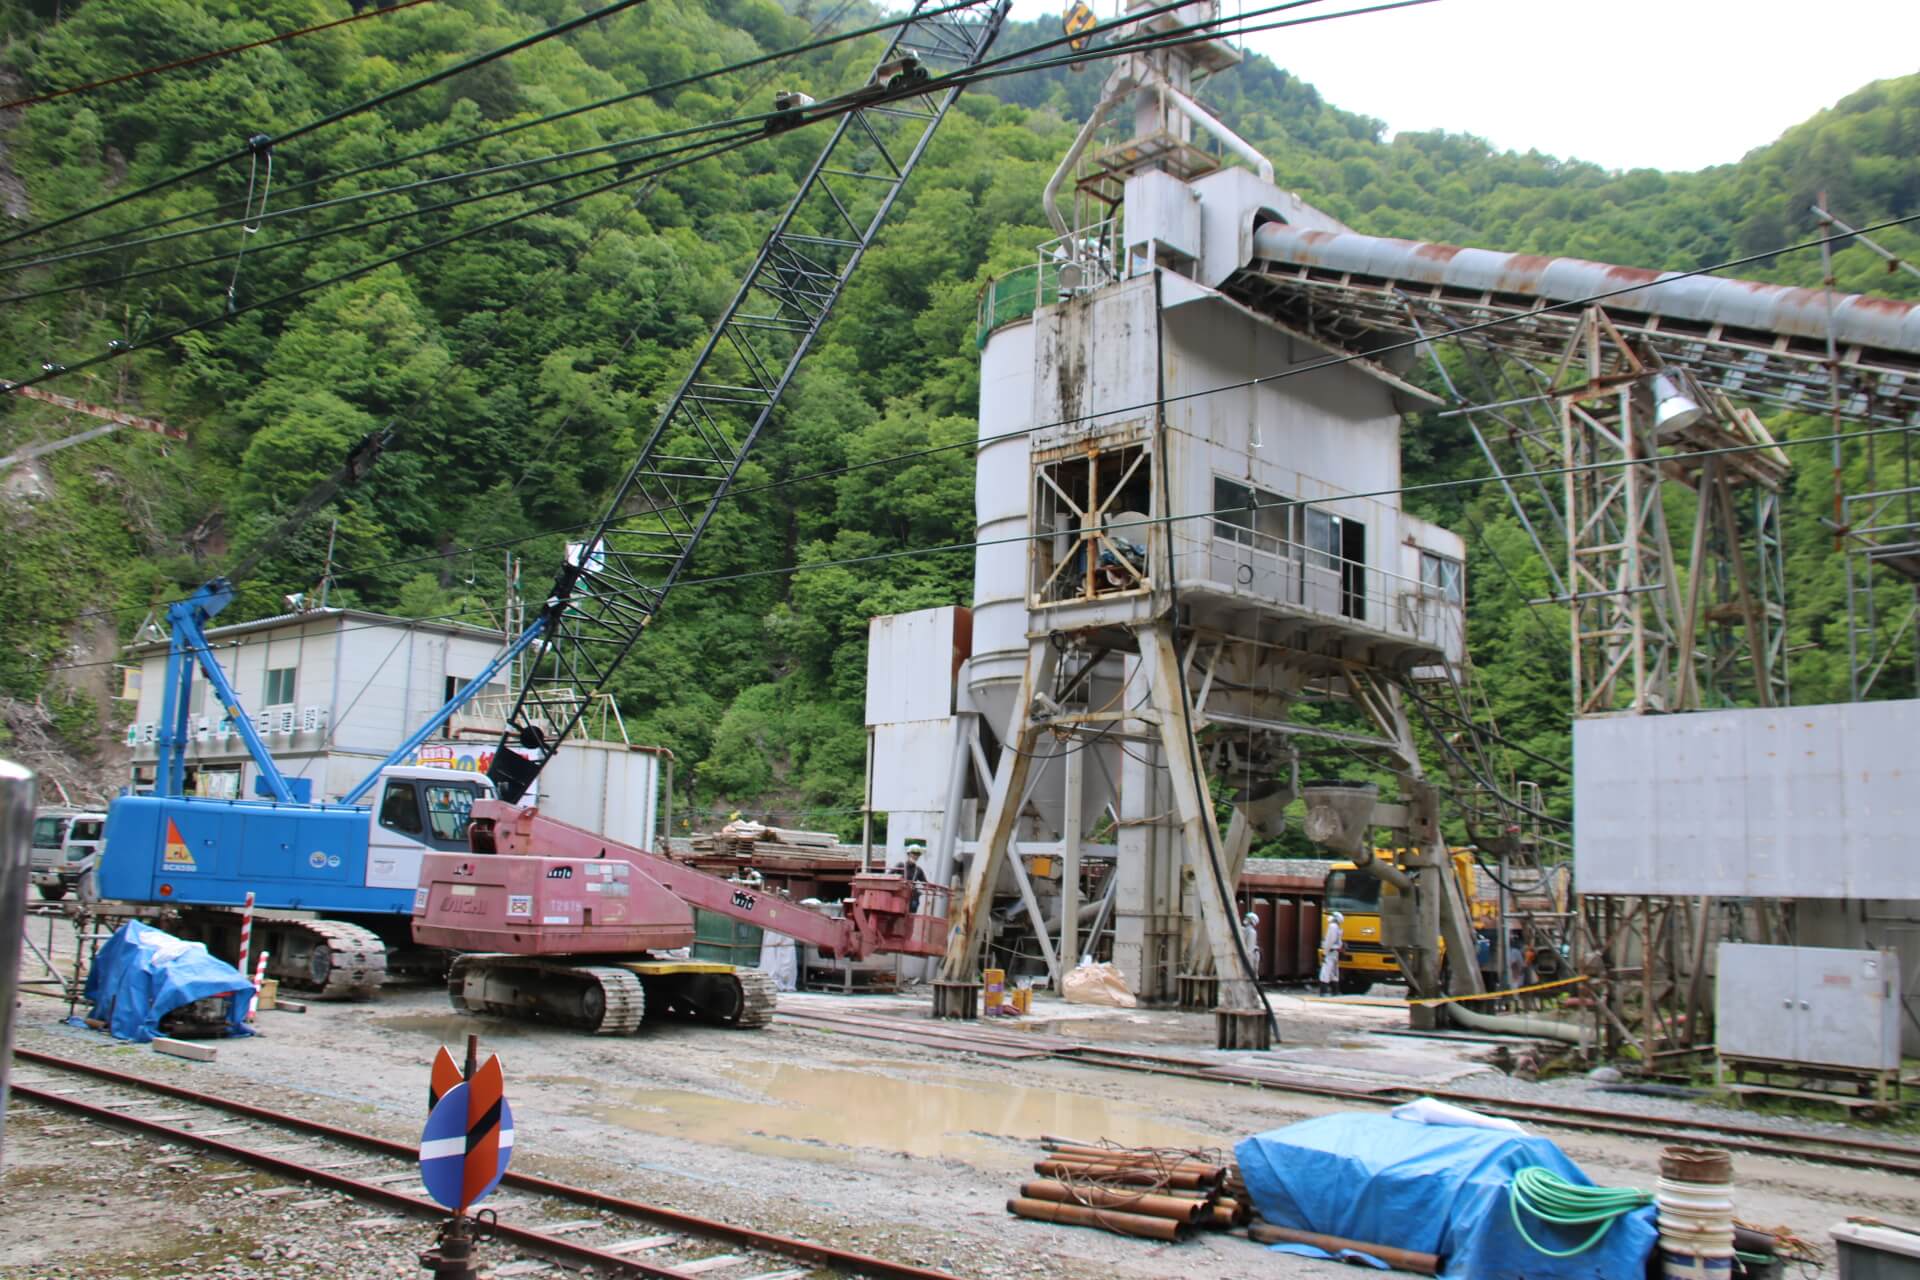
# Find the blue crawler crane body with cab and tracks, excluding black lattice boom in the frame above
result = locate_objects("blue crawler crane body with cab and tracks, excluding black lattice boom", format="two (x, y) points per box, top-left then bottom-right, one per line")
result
(96, 580), (547, 998)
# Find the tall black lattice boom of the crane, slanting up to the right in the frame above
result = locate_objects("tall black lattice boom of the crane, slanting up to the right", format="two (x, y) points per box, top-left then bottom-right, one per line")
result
(488, 0), (1008, 800)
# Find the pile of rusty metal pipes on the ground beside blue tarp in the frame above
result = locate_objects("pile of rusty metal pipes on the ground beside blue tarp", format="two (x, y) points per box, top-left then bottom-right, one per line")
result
(1006, 1138), (1252, 1242)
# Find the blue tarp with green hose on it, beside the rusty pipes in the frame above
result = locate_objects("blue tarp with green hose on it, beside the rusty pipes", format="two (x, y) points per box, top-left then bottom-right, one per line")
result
(1235, 1115), (1657, 1280)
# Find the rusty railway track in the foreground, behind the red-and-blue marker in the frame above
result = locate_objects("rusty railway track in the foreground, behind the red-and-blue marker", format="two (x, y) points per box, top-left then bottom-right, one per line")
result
(0, 1050), (956, 1280)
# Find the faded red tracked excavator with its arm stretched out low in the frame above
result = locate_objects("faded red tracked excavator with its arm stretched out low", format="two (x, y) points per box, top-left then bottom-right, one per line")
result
(413, 800), (947, 1036)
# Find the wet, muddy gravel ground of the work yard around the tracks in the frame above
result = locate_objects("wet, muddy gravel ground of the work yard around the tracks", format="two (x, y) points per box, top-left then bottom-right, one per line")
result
(0, 921), (1920, 1280)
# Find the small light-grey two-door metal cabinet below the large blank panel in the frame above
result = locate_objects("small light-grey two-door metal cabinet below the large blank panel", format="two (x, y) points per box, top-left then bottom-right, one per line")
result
(1715, 942), (1901, 1071)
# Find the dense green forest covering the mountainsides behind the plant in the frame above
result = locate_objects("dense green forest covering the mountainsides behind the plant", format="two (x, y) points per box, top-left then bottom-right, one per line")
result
(0, 0), (1920, 829)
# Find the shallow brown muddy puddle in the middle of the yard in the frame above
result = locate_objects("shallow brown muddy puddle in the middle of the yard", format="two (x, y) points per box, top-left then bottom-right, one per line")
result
(595, 1063), (1219, 1161)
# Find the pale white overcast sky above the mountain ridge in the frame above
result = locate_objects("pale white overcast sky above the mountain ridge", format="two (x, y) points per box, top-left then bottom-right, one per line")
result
(1014, 0), (1920, 169)
